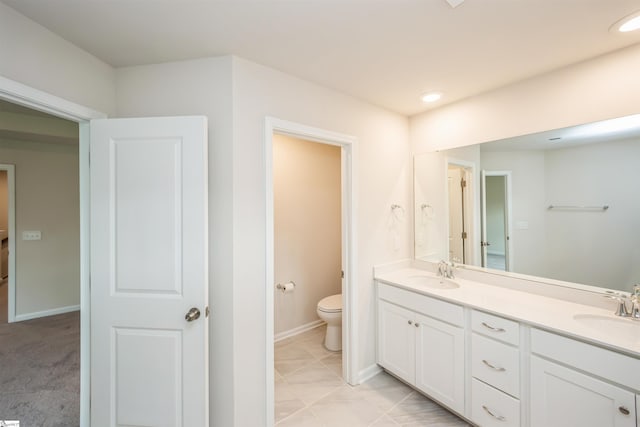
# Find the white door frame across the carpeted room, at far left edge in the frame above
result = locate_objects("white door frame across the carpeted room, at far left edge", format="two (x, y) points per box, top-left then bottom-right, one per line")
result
(0, 164), (16, 323)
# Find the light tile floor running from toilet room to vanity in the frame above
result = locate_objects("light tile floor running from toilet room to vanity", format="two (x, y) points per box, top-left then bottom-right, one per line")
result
(275, 327), (469, 427)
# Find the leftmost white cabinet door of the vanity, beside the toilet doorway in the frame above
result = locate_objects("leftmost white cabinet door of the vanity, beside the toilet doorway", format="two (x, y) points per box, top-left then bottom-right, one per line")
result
(378, 301), (416, 383)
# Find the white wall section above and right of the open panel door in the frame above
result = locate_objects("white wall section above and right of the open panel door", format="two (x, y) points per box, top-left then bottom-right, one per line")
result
(116, 57), (235, 426)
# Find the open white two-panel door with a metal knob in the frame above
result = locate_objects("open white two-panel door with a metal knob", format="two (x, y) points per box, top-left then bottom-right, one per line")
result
(90, 117), (209, 427)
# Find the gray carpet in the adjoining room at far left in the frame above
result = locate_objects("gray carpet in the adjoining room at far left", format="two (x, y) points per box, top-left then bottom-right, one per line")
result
(0, 281), (80, 427)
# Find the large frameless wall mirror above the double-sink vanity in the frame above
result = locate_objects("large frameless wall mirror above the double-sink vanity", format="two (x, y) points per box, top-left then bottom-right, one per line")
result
(414, 115), (640, 291)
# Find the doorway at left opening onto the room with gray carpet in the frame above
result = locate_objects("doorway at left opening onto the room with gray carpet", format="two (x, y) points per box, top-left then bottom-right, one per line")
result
(0, 100), (80, 426)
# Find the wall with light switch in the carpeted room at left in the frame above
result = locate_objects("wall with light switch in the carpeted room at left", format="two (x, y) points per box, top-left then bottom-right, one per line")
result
(0, 140), (80, 319)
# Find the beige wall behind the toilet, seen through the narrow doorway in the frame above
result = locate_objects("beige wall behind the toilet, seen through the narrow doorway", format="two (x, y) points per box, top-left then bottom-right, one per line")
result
(267, 135), (342, 337)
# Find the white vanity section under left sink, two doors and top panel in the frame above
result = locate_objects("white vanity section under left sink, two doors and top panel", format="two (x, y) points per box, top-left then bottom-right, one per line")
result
(378, 283), (464, 413)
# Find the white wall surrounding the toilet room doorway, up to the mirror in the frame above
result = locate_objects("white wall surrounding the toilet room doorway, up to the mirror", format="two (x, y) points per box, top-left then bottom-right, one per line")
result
(233, 58), (412, 426)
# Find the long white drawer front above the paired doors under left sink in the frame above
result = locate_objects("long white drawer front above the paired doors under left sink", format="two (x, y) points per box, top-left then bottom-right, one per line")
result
(378, 283), (464, 326)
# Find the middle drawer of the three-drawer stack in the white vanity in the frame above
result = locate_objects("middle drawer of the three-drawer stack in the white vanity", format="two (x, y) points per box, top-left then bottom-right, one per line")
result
(471, 333), (520, 397)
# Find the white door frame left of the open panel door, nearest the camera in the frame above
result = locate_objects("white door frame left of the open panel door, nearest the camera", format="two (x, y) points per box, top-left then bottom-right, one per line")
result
(0, 76), (107, 427)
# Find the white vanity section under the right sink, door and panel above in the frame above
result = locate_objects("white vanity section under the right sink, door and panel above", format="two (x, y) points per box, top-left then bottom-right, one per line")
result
(530, 329), (640, 427)
